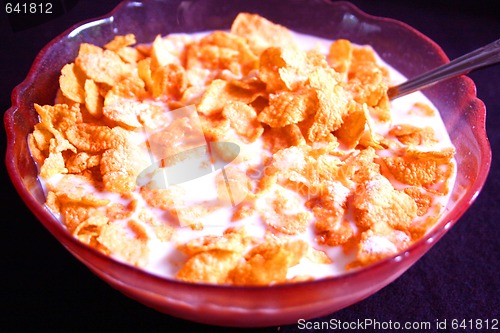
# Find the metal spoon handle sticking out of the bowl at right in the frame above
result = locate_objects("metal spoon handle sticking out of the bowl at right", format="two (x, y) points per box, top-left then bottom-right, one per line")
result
(387, 39), (500, 100)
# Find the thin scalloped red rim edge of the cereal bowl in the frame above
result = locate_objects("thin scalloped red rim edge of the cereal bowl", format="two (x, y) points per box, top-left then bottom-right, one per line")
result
(4, 0), (492, 291)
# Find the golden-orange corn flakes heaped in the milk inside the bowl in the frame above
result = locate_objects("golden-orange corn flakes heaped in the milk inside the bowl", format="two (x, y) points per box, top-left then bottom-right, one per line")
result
(28, 13), (454, 285)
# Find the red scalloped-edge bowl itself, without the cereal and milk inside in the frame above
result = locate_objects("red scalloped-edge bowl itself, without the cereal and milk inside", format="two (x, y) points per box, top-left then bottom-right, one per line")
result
(1, 0), (491, 326)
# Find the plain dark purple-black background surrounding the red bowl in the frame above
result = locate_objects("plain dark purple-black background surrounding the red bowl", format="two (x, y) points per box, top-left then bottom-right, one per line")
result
(0, 0), (500, 332)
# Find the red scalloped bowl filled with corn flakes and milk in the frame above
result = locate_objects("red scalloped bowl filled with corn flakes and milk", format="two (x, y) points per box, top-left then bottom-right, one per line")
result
(5, 0), (491, 327)
